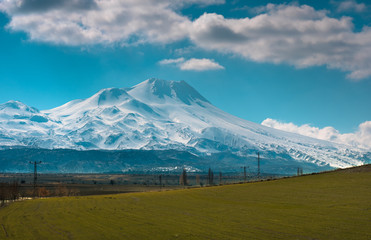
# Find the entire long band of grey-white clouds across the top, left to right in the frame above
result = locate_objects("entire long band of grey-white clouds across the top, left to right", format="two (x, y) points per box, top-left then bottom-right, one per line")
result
(0, 0), (371, 80)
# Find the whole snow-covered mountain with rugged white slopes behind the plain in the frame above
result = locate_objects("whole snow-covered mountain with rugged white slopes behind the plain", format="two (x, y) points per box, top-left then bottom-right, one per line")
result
(0, 79), (370, 172)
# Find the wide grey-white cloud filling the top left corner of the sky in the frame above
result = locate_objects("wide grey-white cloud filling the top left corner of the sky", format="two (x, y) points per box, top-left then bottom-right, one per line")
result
(0, 0), (195, 45)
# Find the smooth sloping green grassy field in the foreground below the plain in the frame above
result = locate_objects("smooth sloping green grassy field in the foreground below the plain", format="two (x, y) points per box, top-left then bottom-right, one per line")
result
(0, 166), (371, 240)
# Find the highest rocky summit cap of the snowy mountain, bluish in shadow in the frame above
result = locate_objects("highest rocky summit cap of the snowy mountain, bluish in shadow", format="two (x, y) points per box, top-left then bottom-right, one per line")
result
(128, 78), (209, 105)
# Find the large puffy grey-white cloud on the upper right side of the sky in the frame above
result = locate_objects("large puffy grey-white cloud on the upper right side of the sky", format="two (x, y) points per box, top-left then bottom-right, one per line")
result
(191, 4), (371, 79)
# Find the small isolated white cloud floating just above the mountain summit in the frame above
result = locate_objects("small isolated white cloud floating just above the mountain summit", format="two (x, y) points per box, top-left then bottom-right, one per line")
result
(159, 57), (224, 71)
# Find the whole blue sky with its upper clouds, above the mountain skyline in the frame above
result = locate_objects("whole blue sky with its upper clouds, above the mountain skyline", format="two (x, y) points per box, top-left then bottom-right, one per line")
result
(0, 0), (371, 141)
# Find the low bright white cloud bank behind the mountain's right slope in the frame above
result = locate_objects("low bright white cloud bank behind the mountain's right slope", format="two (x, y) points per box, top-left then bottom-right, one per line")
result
(261, 118), (371, 150)
